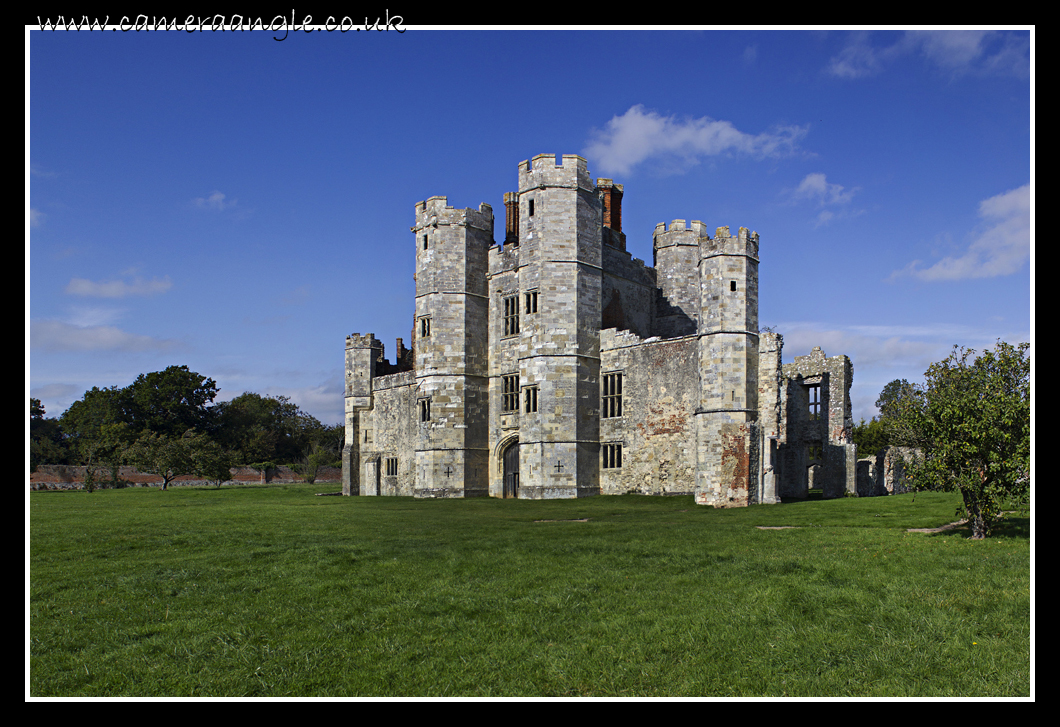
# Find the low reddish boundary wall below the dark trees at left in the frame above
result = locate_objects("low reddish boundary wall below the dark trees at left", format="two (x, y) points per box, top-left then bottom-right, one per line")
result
(30, 464), (342, 490)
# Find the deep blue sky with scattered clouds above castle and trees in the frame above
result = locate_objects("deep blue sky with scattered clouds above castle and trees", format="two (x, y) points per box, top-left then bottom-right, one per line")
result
(25, 27), (1034, 424)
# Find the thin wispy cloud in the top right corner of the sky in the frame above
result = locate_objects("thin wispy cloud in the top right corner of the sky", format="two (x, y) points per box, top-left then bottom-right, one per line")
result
(825, 30), (1030, 78)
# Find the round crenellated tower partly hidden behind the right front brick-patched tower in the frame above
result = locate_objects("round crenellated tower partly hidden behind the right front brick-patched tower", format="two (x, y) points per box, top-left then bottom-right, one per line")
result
(652, 219), (708, 338)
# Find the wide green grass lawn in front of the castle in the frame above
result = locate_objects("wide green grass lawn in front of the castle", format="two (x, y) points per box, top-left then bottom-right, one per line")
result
(29, 483), (1030, 696)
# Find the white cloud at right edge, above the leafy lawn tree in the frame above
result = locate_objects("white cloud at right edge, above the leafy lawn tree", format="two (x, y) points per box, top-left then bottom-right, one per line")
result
(888, 184), (1030, 281)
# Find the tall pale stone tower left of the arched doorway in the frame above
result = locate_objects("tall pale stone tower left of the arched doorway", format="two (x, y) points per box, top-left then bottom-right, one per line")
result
(411, 197), (493, 497)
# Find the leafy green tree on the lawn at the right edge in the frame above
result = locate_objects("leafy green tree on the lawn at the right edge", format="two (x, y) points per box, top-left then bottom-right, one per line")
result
(896, 340), (1030, 539)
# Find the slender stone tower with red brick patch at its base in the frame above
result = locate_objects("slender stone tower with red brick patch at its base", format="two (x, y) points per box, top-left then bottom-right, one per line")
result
(695, 227), (761, 507)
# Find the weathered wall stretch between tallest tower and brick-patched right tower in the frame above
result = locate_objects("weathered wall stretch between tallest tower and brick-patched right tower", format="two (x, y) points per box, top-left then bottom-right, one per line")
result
(600, 330), (700, 495)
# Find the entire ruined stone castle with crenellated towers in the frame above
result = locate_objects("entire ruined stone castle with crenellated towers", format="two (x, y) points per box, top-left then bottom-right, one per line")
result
(342, 155), (854, 507)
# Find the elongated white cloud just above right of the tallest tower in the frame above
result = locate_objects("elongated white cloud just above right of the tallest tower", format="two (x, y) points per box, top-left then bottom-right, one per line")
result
(584, 104), (807, 174)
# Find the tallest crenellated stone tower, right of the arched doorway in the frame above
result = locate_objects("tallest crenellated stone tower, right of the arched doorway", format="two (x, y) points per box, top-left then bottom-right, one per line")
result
(506, 155), (606, 499)
